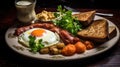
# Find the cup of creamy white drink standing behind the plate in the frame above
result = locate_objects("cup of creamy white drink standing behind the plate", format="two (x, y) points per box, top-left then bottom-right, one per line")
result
(15, 0), (36, 23)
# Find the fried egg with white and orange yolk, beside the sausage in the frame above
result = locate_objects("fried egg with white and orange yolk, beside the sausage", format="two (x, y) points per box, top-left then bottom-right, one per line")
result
(18, 28), (60, 47)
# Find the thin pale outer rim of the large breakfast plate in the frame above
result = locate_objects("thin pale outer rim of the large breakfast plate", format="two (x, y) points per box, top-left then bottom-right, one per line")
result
(5, 15), (120, 61)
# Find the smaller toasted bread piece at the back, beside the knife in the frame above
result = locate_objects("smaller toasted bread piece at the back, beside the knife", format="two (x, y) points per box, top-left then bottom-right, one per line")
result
(73, 10), (96, 26)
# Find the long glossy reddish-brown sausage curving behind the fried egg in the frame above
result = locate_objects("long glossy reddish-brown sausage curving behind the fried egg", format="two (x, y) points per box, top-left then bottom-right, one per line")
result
(14, 23), (79, 44)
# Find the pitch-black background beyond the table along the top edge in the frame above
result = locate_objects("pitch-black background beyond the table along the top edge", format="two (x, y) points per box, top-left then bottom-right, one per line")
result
(0, 0), (120, 10)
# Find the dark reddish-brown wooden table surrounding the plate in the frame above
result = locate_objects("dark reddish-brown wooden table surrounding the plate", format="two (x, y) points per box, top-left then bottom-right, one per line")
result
(0, 8), (120, 67)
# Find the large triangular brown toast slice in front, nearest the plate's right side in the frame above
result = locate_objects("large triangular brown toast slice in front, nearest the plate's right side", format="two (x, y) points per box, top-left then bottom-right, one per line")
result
(77, 19), (109, 42)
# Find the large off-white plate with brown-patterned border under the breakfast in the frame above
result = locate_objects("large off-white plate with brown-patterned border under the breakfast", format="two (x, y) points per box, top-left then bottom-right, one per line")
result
(5, 16), (120, 60)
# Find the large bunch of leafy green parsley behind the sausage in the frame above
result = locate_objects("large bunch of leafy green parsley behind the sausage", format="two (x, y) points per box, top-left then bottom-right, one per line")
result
(53, 5), (82, 35)
